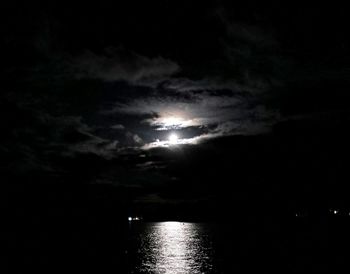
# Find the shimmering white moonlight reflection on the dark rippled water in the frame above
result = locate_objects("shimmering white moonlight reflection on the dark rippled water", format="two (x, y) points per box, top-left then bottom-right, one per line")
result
(134, 222), (213, 274)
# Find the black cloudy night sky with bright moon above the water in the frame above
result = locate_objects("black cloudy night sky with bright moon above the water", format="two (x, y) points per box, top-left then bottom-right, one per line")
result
(0, 0), (350, 218)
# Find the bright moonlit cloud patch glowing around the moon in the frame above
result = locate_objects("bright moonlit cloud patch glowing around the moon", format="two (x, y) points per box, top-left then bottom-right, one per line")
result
(101, 89), (279, 147)
